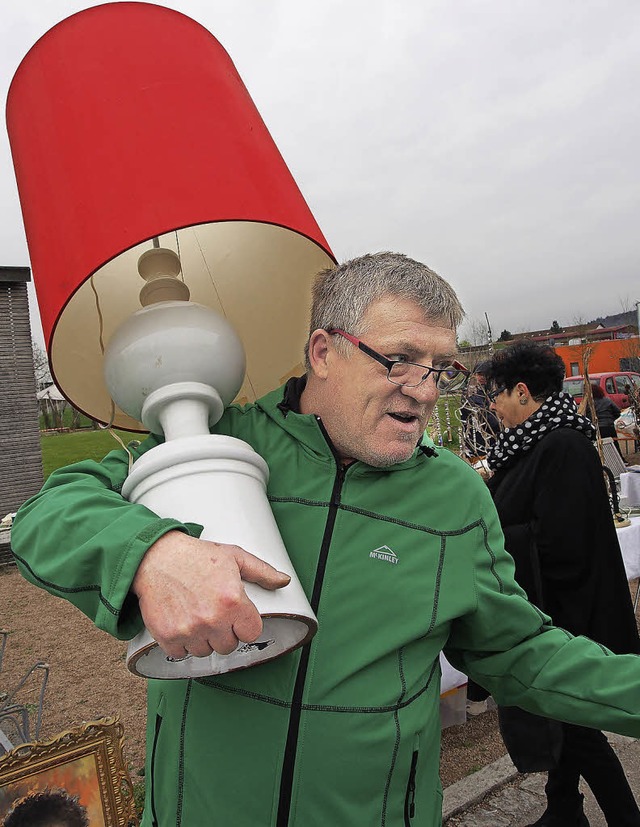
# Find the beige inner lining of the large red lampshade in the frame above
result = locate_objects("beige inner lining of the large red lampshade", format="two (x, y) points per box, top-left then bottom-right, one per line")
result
(50, 221), (333, 431)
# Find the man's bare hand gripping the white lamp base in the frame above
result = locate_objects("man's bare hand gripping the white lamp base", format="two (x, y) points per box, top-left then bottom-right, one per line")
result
(132, 531), (291, 658)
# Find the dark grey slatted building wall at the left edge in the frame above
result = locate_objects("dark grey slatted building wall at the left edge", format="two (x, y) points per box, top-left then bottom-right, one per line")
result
(0, 267), (42, 532)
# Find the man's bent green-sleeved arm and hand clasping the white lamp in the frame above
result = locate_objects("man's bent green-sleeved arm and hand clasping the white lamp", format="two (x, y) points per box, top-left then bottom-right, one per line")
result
(11, 440), (289, 656)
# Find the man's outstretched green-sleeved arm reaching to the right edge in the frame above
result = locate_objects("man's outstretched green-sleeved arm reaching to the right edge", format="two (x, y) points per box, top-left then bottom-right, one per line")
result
(444, 486), (640, 737)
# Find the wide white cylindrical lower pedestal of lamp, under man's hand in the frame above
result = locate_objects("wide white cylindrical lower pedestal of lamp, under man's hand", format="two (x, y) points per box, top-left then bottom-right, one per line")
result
(122, 434), (318, 679)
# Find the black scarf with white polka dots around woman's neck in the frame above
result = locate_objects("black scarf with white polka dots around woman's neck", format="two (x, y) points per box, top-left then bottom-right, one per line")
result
(487, 391), (595, 471)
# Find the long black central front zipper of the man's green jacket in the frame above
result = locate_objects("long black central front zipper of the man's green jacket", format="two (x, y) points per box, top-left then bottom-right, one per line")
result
(276, 417), (347, 827)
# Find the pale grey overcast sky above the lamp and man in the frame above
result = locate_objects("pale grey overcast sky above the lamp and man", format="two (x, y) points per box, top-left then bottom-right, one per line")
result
(0, 0), (640, 344)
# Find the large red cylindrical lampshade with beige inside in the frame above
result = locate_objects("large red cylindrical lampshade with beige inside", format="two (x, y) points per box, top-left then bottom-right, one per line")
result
(7, 2), (334, 430)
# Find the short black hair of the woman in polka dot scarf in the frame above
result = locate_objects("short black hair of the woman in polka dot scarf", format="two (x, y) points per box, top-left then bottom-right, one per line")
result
(487, 339), (564, 402)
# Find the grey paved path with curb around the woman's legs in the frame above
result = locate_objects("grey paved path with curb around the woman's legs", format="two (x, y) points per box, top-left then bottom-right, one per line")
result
(443, 735), (640, 827)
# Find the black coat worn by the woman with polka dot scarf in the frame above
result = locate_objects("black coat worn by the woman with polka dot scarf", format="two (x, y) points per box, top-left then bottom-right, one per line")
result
(489, 428), (640, 653)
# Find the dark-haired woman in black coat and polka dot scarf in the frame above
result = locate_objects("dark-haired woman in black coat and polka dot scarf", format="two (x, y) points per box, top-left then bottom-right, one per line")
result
(488, 341), (640, 827)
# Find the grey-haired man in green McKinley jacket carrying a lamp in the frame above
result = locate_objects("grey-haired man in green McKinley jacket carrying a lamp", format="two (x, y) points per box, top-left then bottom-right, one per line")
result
(12, 253), (640, 827)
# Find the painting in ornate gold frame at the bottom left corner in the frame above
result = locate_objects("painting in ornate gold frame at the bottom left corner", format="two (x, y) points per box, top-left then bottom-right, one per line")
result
(0, 718), (138, 827)
